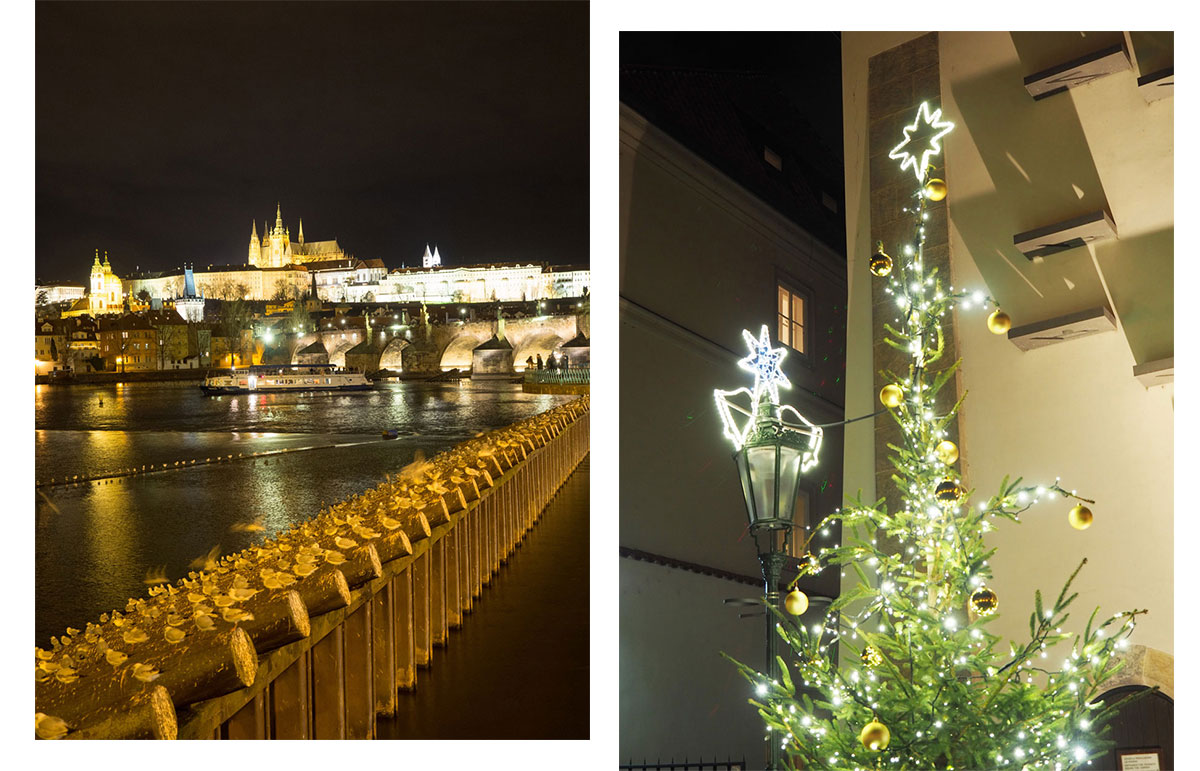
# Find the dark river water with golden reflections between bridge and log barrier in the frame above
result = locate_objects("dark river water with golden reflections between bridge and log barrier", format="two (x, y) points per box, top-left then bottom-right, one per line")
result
(35, 381), (574, 646)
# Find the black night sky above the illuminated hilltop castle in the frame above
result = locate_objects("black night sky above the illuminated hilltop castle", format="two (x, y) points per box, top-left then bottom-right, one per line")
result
(35, 2), (588, 281)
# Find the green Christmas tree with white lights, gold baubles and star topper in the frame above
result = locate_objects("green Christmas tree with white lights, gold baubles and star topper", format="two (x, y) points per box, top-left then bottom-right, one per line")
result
(737, 104), (1145, 771)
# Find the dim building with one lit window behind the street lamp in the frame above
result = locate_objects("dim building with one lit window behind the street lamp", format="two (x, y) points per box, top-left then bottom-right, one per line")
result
(624, 58), (846, 769)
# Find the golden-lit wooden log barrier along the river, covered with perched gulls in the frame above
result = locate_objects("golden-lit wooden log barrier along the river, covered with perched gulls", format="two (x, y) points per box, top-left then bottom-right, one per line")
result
(35, 396), (589, 739)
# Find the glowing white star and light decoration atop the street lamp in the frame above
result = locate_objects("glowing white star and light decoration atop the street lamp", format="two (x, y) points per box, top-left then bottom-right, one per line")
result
(713, 324), (823, 471)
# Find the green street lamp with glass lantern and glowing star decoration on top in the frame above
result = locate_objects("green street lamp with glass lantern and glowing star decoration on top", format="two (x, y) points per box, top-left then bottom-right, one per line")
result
(713, 324), (823, 771)
